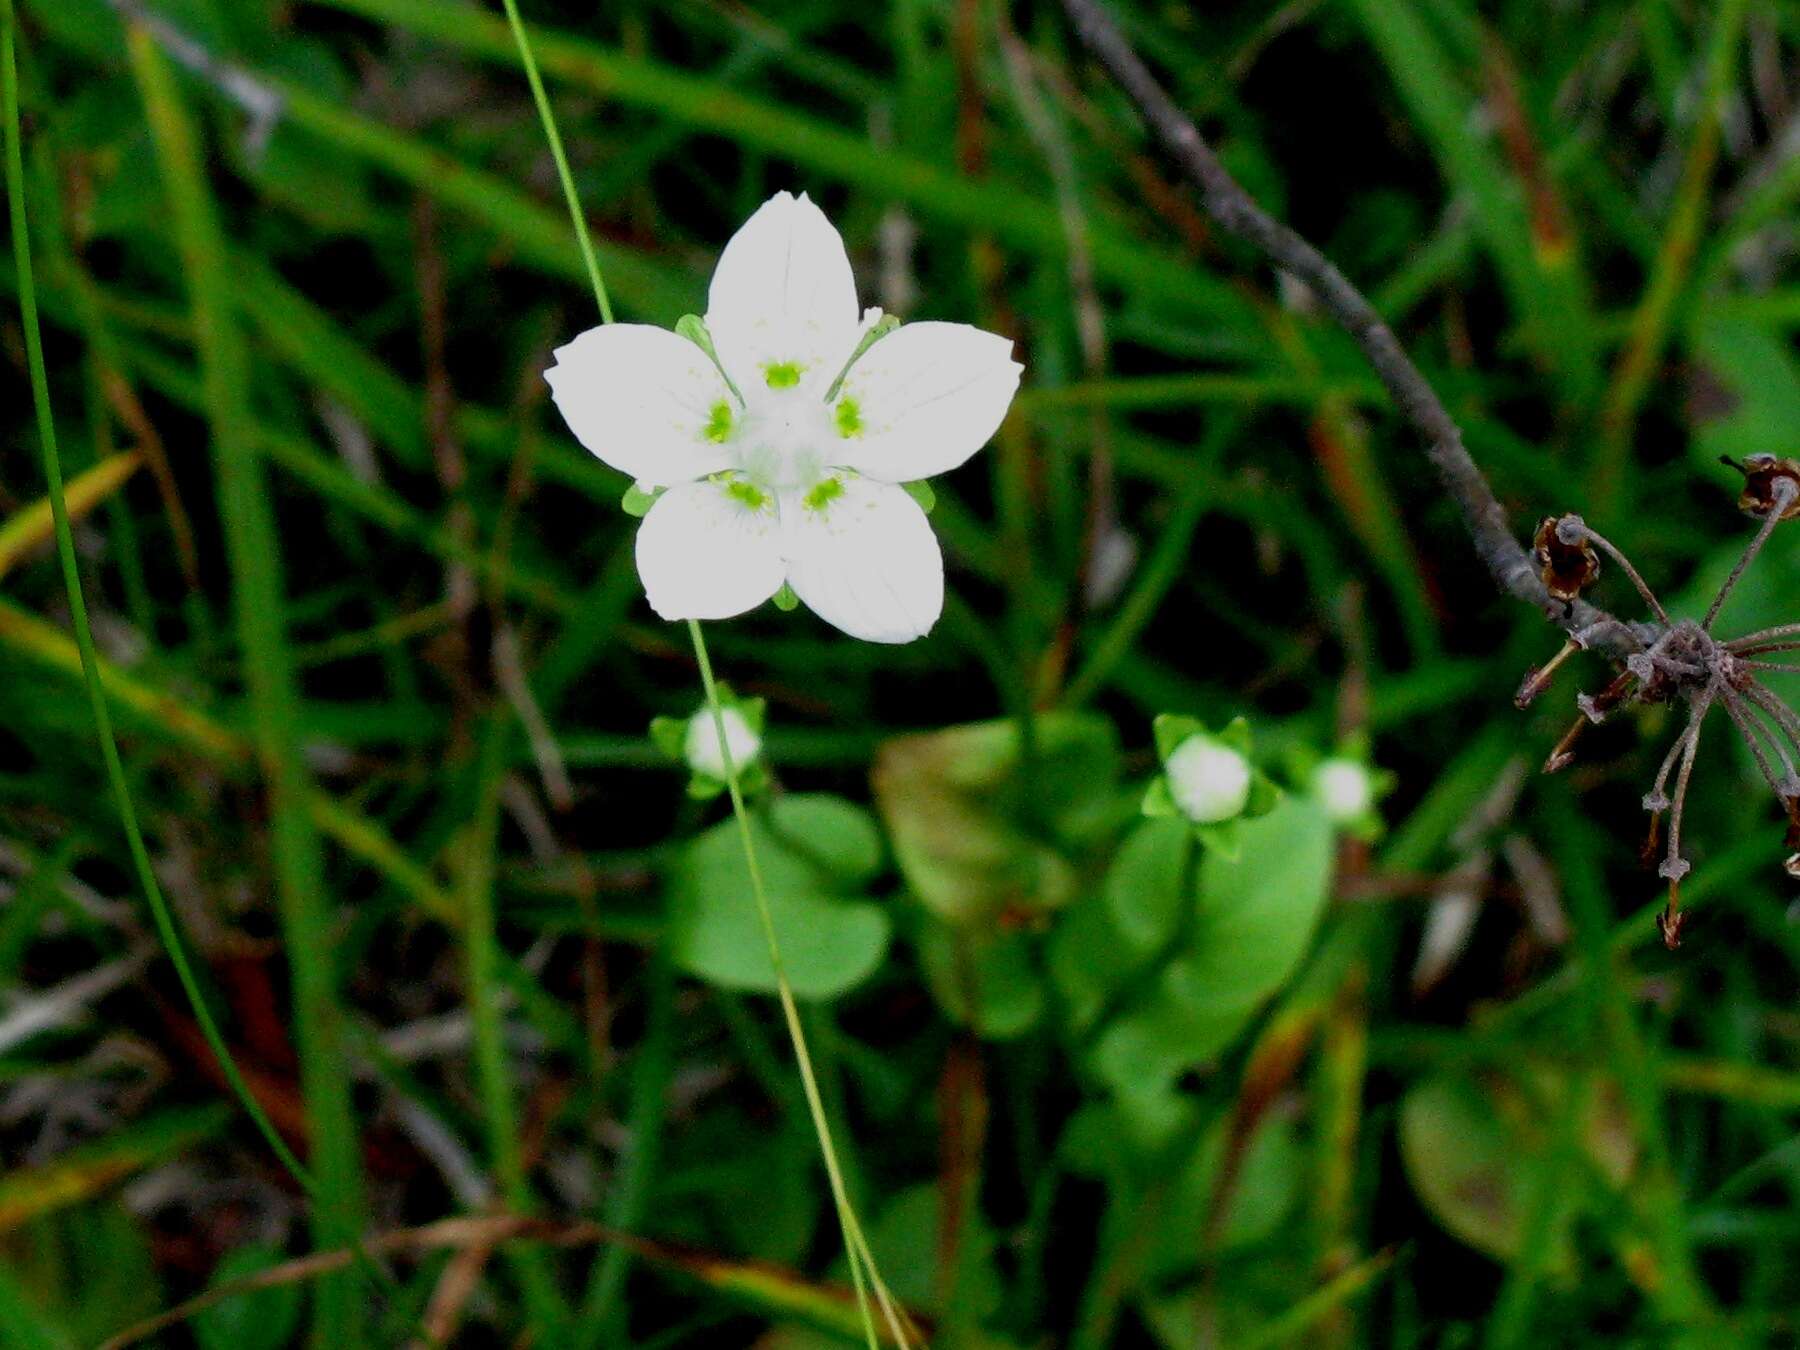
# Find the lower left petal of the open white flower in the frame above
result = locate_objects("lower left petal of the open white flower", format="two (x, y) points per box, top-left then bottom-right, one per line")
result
(637, 479), (785, 619)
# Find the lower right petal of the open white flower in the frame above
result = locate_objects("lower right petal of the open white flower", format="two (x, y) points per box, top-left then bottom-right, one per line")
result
(781, 473), (943, 643)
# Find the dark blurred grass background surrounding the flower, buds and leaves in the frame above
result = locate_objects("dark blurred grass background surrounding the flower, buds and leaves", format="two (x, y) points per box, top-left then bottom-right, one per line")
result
(0, 0), (1800, 1346)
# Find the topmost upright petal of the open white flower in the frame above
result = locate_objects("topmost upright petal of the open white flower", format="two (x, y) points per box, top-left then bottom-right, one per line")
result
(706, 193), (857, 396)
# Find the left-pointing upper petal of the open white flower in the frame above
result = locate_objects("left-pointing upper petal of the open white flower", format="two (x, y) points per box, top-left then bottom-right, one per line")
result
(544, 324), (736, 488)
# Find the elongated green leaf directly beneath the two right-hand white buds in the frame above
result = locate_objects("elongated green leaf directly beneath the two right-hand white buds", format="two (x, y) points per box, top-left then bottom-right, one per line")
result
(1094, 797), (1332, 1091)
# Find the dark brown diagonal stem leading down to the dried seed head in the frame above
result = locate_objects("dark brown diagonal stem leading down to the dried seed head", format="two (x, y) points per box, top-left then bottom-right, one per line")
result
(1062, 0), (1634, 655)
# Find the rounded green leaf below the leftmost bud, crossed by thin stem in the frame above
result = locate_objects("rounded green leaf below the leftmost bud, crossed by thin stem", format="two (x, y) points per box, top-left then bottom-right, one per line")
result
(670, 796), (891, 999)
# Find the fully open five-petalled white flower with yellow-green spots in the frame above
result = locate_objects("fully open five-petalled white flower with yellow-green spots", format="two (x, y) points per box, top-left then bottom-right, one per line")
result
(547, 193), (1021, 643)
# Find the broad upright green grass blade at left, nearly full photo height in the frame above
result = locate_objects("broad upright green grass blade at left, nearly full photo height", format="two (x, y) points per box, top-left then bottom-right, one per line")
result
(128, 23), (364, 1346)
